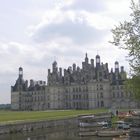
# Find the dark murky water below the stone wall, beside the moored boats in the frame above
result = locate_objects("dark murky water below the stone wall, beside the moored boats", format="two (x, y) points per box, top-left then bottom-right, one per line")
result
(0, 128), (140, 140)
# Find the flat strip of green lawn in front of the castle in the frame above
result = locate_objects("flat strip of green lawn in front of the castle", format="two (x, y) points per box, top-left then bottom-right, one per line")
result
(0, 109), (108, 124)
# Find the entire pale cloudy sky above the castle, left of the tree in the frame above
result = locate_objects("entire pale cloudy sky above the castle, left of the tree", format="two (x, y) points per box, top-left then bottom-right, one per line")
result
(0, 0), (131, 104)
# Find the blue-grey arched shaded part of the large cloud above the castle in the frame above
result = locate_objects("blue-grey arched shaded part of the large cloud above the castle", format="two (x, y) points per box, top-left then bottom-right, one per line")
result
(32, 20), (105, 45)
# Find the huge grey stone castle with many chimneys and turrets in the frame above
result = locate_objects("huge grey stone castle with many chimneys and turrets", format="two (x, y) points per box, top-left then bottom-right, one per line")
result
(11, 54), (137, 110)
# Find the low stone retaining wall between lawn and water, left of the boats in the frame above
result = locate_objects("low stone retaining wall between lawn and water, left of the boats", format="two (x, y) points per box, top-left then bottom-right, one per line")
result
(0, 118), (78, 134)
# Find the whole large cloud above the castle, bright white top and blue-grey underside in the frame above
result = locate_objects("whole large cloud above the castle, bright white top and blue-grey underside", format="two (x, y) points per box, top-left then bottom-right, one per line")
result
(28, 9), (108, 45)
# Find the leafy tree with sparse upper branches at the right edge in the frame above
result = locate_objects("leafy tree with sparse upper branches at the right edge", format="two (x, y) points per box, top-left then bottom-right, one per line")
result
(110, 0), (140, 99)
